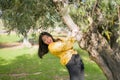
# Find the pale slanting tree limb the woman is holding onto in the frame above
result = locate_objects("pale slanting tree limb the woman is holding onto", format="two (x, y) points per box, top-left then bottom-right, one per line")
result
(53, 0), (82, 41)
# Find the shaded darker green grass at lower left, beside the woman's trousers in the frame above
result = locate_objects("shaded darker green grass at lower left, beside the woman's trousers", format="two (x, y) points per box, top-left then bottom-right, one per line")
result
(0, 54), (68, 80)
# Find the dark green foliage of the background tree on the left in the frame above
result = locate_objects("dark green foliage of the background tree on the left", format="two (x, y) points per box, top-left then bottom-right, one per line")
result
(0, 0), (60, 36)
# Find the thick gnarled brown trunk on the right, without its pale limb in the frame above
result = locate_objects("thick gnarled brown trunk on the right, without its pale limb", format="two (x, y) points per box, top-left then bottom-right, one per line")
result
(79, 26), (120, 80)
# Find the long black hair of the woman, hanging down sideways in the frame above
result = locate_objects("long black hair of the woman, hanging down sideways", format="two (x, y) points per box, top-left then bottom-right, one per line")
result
(38, 32), (55, 58)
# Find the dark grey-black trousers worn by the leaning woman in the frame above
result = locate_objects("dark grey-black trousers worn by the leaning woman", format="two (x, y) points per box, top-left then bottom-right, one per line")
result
(66, 54), (84, 80)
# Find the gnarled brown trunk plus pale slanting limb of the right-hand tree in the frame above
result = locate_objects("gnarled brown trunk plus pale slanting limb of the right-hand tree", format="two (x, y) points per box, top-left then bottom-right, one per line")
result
(53, 0), (120, 80)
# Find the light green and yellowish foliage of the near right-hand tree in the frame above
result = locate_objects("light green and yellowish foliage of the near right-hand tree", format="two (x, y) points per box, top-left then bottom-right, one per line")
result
(69, 0), (120, 41)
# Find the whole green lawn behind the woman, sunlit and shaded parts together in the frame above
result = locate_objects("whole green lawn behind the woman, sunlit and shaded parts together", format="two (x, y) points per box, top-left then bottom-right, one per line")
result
(0, 36), (107, 80)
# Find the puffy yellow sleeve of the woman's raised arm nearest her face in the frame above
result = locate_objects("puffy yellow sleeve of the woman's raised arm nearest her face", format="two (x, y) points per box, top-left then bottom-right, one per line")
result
(48, 37), (75, 53)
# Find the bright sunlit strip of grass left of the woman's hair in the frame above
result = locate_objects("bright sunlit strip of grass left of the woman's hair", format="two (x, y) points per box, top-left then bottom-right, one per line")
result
(0, 47), (36, 60)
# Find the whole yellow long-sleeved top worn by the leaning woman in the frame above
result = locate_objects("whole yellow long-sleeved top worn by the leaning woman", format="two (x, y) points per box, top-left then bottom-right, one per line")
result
(48, 37), (77, 65)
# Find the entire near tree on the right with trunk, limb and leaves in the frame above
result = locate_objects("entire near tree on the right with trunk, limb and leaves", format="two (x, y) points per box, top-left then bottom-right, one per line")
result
(53, 0), (120, 80)
